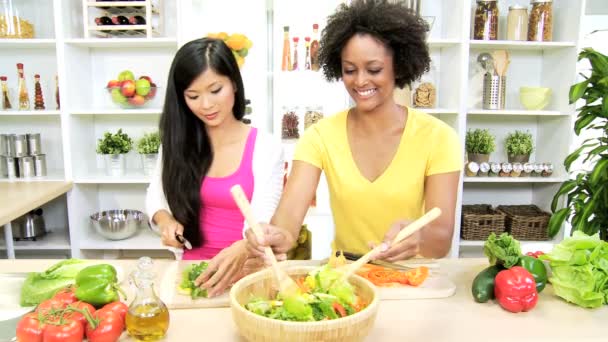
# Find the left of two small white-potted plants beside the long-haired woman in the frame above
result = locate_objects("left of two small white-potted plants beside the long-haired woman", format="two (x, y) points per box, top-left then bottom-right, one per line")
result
(97, 129), (133, 176)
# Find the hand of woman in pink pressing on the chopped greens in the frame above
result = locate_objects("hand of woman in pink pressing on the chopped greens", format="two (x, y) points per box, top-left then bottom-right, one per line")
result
(194, 240), (249, 297)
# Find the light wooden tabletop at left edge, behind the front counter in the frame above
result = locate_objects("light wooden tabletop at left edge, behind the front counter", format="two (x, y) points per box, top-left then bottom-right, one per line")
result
(0, 181), (72, 226)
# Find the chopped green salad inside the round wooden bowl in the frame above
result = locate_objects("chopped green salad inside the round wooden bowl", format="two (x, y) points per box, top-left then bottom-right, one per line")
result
(245, 264), (367, 322)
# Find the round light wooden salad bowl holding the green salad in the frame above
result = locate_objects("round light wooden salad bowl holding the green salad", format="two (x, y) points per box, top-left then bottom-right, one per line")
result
(230, 266), (378, 342)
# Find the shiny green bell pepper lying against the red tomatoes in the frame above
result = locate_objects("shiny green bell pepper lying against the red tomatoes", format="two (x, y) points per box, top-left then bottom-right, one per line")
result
(76, 264), (127, 306)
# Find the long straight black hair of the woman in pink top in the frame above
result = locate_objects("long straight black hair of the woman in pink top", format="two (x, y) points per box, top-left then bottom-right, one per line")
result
(159, 38), (245, 246)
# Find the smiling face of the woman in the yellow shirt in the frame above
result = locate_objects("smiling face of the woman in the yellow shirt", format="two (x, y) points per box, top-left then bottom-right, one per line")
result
(341, 34), (395, 112)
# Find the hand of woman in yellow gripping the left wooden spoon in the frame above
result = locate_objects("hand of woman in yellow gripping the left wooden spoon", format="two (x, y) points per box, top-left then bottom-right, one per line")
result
(245, 223), (296, 261)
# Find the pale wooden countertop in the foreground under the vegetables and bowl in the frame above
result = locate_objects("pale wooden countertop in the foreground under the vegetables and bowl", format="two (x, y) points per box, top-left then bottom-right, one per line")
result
(0, 259), (608, 342)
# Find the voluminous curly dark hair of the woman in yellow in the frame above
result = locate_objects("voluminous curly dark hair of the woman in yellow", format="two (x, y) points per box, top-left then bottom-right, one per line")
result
(319, 0), (431, 88)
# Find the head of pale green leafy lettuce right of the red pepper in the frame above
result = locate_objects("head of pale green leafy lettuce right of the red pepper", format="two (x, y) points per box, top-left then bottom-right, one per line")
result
(539, 231), (608, 308)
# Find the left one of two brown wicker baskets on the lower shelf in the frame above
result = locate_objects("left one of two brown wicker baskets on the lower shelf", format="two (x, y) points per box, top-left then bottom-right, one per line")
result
(460, 204), (506, 241)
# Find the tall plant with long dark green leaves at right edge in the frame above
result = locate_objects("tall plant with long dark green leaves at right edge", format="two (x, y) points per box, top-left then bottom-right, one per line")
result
(548, 49), (608, 240)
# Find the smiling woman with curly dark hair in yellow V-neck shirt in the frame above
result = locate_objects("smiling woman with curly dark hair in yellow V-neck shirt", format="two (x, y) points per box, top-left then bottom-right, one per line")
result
(247, 0), (462, 262)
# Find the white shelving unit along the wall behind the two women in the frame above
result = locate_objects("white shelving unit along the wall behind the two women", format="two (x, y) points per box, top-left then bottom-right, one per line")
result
(0, 0), (585, 257)
